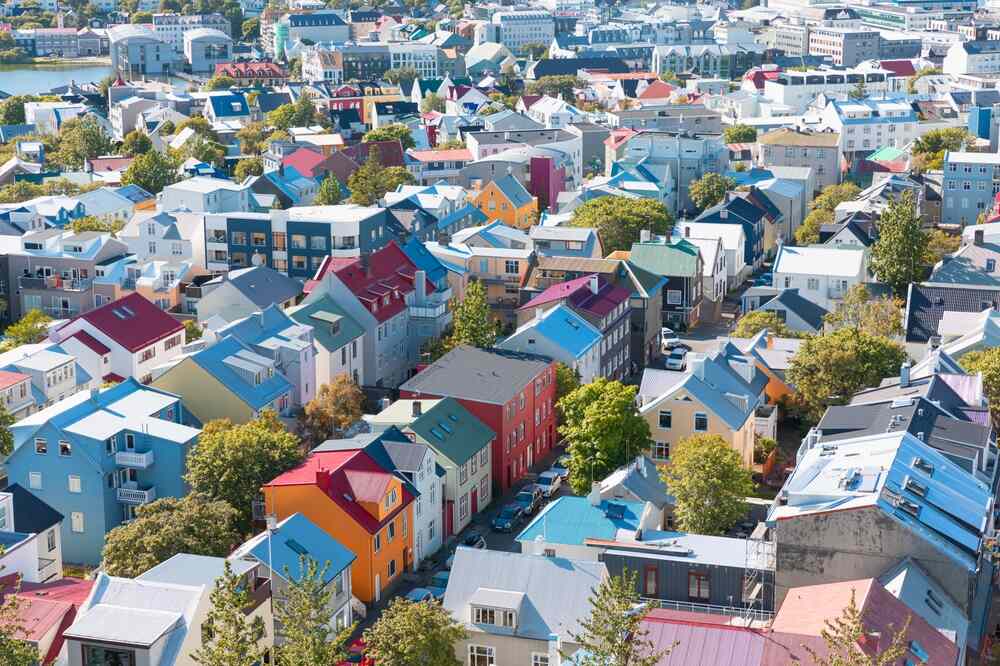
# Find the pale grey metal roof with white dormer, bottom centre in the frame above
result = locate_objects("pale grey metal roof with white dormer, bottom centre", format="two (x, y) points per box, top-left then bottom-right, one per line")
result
(444, 547), (608, 641)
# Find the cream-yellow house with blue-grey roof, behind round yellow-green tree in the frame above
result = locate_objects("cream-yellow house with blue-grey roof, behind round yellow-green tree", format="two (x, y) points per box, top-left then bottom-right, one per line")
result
(639, 344), (767, 467)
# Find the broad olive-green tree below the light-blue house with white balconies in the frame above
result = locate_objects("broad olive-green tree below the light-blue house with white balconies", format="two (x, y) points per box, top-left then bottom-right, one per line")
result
(101, 493), (240, 578)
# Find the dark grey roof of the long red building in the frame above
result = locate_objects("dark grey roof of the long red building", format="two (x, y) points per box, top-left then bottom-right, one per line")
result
(399, 345), (552, 405)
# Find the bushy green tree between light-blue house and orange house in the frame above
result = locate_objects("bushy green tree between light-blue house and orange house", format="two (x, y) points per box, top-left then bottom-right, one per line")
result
(184, 409), (304, 531)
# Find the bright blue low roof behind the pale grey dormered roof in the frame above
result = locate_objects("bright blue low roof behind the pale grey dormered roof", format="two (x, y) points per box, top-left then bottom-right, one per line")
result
(517, 495), (645, 546)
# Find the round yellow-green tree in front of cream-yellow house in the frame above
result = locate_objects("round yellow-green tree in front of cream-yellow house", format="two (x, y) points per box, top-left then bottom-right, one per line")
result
(664, 434), (753, 534)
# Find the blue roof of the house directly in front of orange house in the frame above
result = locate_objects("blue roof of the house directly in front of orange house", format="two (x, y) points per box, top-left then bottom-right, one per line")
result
(243, 513), (356, 583)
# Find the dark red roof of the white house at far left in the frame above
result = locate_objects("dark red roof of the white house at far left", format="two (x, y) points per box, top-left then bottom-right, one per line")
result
(59, 293), (184, 352)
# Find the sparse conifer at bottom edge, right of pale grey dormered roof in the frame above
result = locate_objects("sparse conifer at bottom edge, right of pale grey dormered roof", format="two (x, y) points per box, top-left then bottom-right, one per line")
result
(563, 569), (670, 666)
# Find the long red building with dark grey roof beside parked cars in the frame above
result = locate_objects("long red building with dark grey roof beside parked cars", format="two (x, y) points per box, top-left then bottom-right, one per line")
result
(399, 345), (556, 496)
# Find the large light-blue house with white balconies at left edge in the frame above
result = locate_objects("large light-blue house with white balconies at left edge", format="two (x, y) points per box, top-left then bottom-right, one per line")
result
(5, 378), (201, 564)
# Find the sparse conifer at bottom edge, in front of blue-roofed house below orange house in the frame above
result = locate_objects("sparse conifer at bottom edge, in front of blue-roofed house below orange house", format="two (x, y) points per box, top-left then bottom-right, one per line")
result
(274, 556), (356, 666)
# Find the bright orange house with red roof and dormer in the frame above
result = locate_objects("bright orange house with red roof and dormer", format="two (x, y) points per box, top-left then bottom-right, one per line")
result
(263, 450), (414, 604)
